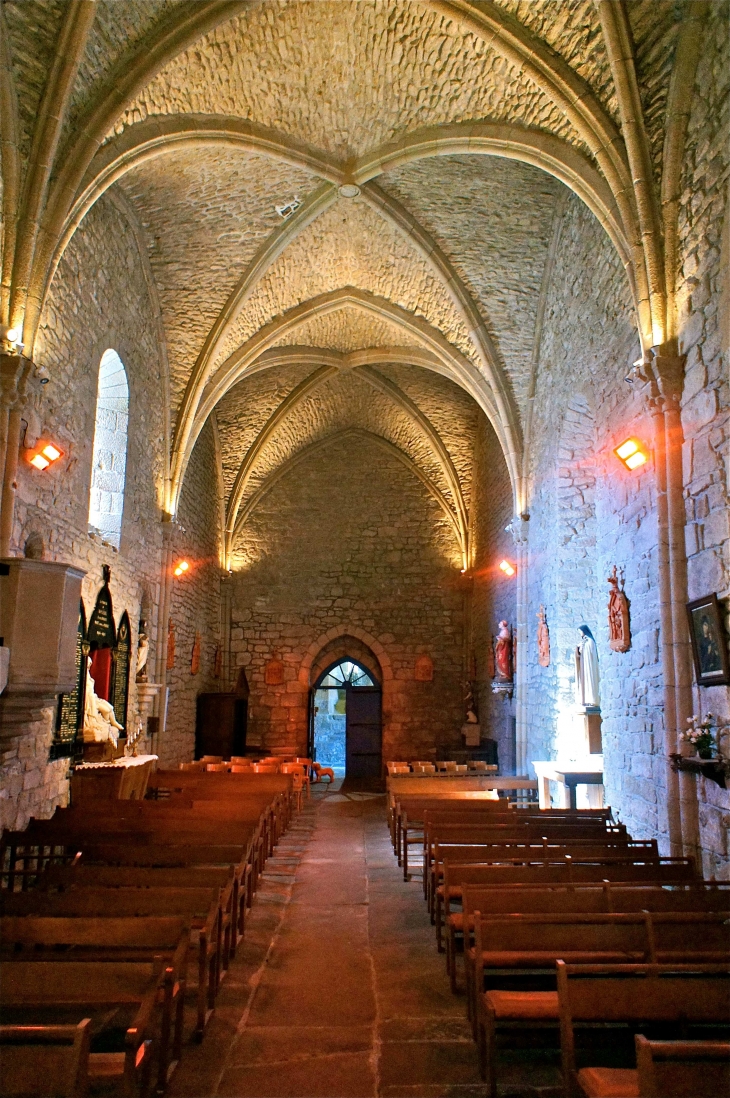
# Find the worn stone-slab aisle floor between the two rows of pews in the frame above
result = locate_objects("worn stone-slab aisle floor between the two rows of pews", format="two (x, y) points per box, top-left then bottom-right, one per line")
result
(169, 782), (559, 1098)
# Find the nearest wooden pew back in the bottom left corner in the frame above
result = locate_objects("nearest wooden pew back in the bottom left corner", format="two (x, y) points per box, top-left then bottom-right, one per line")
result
(0, 1018), (91, 1098)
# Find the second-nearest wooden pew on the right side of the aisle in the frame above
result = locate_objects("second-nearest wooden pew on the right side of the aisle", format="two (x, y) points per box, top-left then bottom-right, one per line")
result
(557, 961), (730, 1098)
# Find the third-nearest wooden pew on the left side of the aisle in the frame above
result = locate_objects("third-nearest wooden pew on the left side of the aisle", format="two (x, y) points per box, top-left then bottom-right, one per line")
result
(0, 916), (190, 1089)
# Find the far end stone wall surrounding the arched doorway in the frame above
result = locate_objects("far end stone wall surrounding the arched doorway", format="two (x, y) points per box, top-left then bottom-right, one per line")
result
(232, 436), (463, 759)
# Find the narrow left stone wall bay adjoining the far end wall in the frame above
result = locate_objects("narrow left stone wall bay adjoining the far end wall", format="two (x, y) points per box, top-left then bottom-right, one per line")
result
(163, 421), (221, 765)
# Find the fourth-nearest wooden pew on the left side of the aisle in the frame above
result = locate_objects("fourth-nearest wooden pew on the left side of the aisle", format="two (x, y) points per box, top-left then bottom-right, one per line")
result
(1, 871), (221, 1038)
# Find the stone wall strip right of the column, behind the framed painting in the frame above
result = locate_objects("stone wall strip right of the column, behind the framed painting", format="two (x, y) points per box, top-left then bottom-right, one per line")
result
(677, 4), (730, 877)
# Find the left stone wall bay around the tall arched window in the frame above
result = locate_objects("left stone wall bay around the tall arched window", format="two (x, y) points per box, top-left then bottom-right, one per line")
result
(0, 191), (216, 827)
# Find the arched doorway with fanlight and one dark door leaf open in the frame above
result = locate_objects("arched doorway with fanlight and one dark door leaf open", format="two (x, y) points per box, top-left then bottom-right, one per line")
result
(310, 657), (382, 778)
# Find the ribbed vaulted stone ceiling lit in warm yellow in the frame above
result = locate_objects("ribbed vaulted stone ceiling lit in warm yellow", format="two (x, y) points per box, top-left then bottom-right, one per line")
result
(3, 0), (683, 562)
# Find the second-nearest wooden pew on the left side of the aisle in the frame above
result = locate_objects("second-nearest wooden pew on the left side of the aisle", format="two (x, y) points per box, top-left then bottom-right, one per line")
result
(0, 961), (172, 1098)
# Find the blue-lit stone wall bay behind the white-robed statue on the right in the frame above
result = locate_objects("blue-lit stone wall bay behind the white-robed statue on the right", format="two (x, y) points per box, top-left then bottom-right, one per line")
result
(527, 198), (667, 845)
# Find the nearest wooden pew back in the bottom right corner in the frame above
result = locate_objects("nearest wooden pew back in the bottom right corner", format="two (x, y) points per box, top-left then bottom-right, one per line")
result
(634, 1033), (730, 1098)
